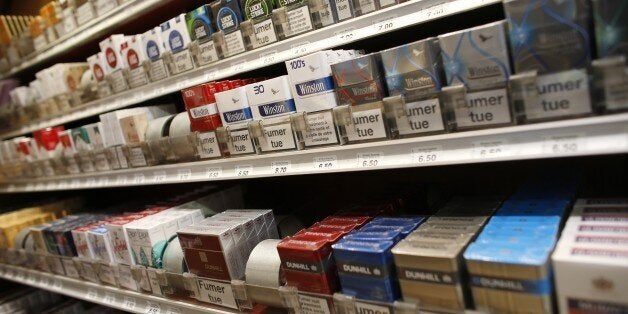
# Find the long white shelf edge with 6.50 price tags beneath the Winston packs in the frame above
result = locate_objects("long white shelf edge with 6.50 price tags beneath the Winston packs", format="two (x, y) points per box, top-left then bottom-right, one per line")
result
(0, 113), (628, 193)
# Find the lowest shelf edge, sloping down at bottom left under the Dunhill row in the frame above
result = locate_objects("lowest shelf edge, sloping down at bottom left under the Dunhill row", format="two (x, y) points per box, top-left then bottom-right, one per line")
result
(0, 264), (239, 314)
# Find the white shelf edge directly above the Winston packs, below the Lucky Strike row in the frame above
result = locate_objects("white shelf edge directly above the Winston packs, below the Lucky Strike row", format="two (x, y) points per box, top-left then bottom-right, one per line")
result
(0, 0), (501, 139)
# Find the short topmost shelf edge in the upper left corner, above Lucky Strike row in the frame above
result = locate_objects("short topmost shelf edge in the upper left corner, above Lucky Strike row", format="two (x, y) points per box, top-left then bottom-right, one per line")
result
(1, 0), (177, 78)
